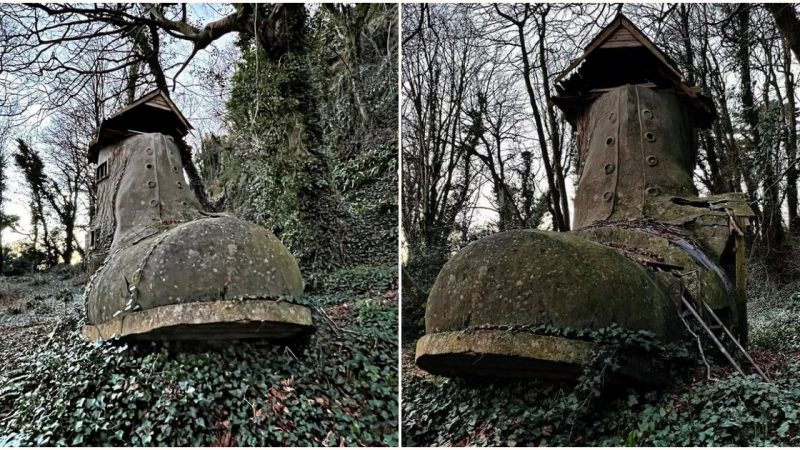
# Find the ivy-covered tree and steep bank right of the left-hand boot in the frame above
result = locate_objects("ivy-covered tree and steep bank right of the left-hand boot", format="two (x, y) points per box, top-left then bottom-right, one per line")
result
(200, 5), (397, 272)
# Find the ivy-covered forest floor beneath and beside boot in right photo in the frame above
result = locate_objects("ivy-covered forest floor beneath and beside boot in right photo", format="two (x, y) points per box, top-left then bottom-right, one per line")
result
(401, 261), (800, 446)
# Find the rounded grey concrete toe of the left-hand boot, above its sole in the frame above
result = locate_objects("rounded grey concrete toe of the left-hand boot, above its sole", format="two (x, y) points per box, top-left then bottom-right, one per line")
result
(87, 217), (303, 323)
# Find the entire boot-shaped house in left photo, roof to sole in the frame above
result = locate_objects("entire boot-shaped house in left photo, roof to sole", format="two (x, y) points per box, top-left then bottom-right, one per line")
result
(84, 91), (312, 340)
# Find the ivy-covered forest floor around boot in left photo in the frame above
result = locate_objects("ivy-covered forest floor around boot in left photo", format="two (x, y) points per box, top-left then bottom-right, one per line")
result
(0, 266), (398, 447)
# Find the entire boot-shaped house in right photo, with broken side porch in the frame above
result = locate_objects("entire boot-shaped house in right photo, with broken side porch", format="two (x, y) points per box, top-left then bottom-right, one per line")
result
(417, 15), (753, 381)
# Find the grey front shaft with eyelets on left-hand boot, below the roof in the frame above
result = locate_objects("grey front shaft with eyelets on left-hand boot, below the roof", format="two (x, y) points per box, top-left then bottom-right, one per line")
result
(114, 133), (202, 247)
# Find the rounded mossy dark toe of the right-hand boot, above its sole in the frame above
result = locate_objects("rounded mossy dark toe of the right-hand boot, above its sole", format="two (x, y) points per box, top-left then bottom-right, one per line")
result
(425, 230), (678, 339)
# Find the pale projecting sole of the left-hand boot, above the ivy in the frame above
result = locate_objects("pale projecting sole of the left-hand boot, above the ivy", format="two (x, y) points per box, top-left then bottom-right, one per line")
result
(83, 300), (313, 341)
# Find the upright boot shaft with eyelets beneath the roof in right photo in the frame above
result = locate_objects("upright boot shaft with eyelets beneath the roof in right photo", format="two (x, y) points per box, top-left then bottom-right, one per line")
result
(574, 85), (697, 229)
